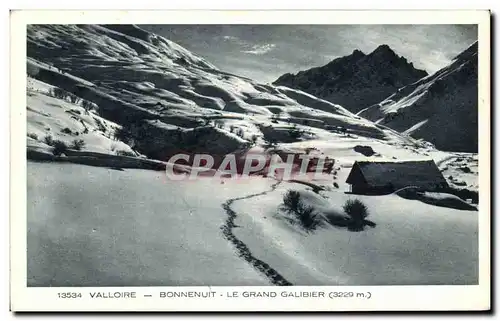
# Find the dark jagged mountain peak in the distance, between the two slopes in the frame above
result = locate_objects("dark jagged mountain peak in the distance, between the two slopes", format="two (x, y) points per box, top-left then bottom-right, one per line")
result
(274, 45), (427, 112)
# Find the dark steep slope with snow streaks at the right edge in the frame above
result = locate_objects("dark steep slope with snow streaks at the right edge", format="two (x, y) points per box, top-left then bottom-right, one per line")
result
(358, 42), (478, 152)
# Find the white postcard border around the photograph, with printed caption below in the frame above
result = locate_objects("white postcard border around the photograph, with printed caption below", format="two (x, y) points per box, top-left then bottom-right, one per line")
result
(10, 10), (491, 311)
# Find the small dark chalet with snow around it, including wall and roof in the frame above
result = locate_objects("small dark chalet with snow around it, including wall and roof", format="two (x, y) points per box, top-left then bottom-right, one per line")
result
(346, 160), (448, 194)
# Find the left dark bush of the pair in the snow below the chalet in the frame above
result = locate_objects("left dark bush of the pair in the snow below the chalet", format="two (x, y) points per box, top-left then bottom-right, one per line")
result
(283, 190), (320, 231)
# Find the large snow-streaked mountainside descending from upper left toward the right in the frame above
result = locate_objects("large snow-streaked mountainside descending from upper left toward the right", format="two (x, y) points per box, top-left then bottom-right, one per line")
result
(27, 25), (414, 160)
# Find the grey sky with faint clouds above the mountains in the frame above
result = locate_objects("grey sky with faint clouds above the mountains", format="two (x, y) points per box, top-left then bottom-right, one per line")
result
(141, 25), (477, 83)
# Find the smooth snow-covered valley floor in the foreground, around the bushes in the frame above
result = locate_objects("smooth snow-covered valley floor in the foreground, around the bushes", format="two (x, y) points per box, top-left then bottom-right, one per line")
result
(27, 161), (478, 286)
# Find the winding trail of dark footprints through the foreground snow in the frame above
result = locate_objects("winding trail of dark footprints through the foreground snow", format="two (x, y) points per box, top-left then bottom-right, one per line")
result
(221, 181), (292, 286)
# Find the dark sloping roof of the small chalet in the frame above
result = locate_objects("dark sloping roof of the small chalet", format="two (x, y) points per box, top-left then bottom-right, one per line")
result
(346, 160), (447, 187)
